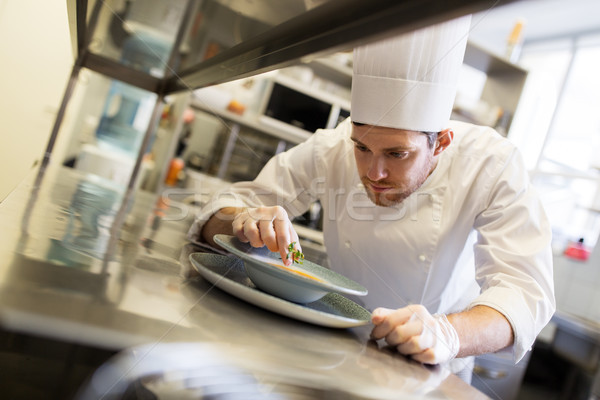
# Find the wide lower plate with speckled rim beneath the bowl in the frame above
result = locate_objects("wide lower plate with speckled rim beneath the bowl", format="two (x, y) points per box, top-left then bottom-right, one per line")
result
(190, 253), (371, 328)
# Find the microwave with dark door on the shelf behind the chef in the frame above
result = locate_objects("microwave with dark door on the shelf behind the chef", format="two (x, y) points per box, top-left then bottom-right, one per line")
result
(258, 74), (350, 138)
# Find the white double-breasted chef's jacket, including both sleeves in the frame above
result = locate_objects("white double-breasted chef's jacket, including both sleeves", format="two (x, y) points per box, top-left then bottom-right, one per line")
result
(190, 119), (555, 362)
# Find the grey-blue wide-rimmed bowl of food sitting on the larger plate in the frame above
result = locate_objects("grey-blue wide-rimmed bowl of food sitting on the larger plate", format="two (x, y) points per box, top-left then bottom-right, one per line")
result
(214, 235), (367, 304)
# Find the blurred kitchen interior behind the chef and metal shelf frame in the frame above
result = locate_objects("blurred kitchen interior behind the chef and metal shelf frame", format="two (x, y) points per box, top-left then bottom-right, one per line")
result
(0, 0), (600, 399)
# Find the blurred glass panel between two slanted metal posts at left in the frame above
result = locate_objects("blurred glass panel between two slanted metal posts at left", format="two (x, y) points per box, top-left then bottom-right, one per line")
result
(56, 70), (157, 185)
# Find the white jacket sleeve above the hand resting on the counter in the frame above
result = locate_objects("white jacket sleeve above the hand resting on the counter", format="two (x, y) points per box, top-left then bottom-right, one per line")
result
(471, 149), (556, 363)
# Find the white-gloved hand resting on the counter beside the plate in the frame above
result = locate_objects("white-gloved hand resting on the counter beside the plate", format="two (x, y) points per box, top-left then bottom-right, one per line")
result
(371, 305), (460, 364)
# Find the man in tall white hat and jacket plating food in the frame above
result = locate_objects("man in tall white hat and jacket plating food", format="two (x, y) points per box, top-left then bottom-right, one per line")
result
(189, 17), (555, 381)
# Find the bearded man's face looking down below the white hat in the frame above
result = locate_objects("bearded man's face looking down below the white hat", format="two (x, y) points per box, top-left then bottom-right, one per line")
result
(351, 124), (451, 206)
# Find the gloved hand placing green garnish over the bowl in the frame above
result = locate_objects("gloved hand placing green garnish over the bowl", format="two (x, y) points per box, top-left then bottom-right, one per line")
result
(232, 206), (302, 265)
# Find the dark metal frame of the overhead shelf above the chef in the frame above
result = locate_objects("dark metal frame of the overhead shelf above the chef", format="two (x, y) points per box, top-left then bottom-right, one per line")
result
(67, 0), (516, 95)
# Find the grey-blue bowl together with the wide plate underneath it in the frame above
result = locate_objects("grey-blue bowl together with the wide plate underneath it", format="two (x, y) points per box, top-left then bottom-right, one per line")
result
(190, 235), (371, 328)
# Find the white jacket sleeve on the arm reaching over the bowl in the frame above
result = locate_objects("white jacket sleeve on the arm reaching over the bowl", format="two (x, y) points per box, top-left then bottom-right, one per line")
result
(187, 131), (325, 241)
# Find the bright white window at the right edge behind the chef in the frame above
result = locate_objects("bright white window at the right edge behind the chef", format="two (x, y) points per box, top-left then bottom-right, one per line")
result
(523, 35), (600, 254)
